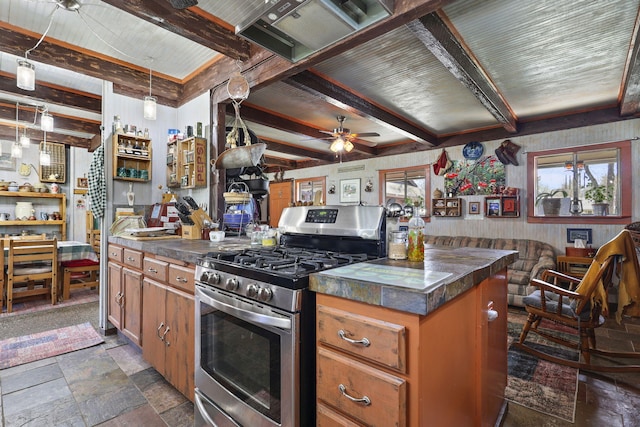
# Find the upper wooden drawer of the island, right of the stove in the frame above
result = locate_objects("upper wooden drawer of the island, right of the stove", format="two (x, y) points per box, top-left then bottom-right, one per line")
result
(316, 305), (407, 373)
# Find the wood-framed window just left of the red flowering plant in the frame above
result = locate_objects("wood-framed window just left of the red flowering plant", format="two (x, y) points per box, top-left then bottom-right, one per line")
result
(380, 166), (429, 217)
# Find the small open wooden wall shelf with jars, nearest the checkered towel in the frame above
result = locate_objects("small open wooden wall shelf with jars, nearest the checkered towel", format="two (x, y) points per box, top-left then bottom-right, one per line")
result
(112, 134), (152, 182)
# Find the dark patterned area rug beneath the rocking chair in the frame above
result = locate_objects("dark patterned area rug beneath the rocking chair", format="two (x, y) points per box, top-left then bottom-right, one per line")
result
(505, 310), (578, 422)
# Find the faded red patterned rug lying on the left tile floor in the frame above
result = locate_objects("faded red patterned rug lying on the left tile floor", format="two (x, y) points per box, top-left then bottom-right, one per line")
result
(0, 322), (104, 369)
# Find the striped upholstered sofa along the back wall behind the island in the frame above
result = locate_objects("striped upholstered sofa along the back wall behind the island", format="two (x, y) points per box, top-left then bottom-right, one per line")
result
(425, 235), (556, 307)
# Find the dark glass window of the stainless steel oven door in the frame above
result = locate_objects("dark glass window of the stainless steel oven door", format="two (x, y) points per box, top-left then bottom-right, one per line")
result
(200, 303), (282, 422)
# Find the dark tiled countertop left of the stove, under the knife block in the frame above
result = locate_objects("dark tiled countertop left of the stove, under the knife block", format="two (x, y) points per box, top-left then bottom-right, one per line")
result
(109, 236), (251, 264)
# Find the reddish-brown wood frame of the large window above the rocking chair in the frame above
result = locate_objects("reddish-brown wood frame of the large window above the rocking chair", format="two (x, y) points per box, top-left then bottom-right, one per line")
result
(527, 140), (633, 224)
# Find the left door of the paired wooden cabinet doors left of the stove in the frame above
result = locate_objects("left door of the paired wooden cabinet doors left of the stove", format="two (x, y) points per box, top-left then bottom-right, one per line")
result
(142, 278), (169, 375)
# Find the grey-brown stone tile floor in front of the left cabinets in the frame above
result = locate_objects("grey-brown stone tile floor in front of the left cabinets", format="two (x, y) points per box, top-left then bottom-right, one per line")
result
(0, 335), (194, 427)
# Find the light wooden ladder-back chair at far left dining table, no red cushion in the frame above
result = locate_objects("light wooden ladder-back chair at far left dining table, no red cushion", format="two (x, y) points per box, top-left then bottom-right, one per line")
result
(6, 239), (58, 313)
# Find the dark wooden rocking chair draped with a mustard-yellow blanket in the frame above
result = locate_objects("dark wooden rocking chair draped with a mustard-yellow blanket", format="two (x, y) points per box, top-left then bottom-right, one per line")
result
(516, 230), (640, 372)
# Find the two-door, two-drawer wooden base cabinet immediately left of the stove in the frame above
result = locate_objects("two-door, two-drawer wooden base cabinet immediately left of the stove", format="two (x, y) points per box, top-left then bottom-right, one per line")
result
(142, 256), (195, 401)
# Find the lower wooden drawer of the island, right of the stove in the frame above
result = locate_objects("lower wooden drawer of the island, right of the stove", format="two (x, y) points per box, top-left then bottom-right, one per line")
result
(316, 347), (407, 427)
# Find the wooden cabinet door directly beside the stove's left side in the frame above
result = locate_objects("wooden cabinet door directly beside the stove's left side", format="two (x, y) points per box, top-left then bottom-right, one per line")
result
(164, 287), (195, 401)
